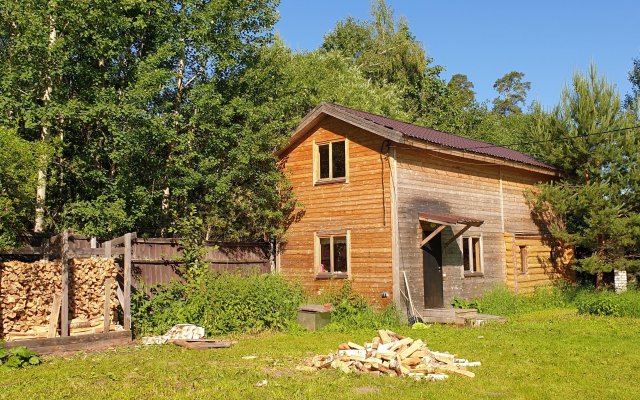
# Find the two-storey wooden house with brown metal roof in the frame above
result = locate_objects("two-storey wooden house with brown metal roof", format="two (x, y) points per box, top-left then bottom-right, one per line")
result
(277, 103), (562, 318)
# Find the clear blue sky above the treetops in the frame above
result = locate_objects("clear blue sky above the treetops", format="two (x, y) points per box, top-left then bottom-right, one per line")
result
(276, 0), (640, 107)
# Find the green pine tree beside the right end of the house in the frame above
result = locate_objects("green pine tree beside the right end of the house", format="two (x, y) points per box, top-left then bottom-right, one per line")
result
(530, 66), (640, 274)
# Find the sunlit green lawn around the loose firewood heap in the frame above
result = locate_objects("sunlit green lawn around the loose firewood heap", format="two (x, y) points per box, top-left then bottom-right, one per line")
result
(0, 309), (640, 400)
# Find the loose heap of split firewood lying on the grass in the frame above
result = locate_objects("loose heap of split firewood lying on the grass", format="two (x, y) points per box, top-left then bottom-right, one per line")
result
(299, 329), (480, 381)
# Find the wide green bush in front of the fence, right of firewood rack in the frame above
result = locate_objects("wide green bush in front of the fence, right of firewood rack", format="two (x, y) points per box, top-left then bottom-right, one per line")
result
(132, 273), (304, 336)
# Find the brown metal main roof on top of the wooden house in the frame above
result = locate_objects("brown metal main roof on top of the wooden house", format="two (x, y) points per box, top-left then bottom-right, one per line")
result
(328, 103), (555, 170)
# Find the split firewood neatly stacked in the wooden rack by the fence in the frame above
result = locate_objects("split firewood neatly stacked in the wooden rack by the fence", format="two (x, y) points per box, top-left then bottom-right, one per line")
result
(0, 258), (118, 337)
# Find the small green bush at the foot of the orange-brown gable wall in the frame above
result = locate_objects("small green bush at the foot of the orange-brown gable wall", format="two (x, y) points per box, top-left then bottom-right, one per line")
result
(316, 281), (402, 331)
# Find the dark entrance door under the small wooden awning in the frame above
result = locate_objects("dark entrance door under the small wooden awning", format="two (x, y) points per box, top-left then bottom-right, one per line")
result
(422, 232), (444, 308)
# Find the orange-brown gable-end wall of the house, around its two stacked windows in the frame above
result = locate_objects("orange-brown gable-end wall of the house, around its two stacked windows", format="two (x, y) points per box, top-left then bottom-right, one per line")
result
(279, 117), (393, 306)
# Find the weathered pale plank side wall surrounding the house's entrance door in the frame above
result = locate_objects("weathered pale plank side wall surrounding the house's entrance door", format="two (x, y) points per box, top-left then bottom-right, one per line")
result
(397, 145), (548, 307)
